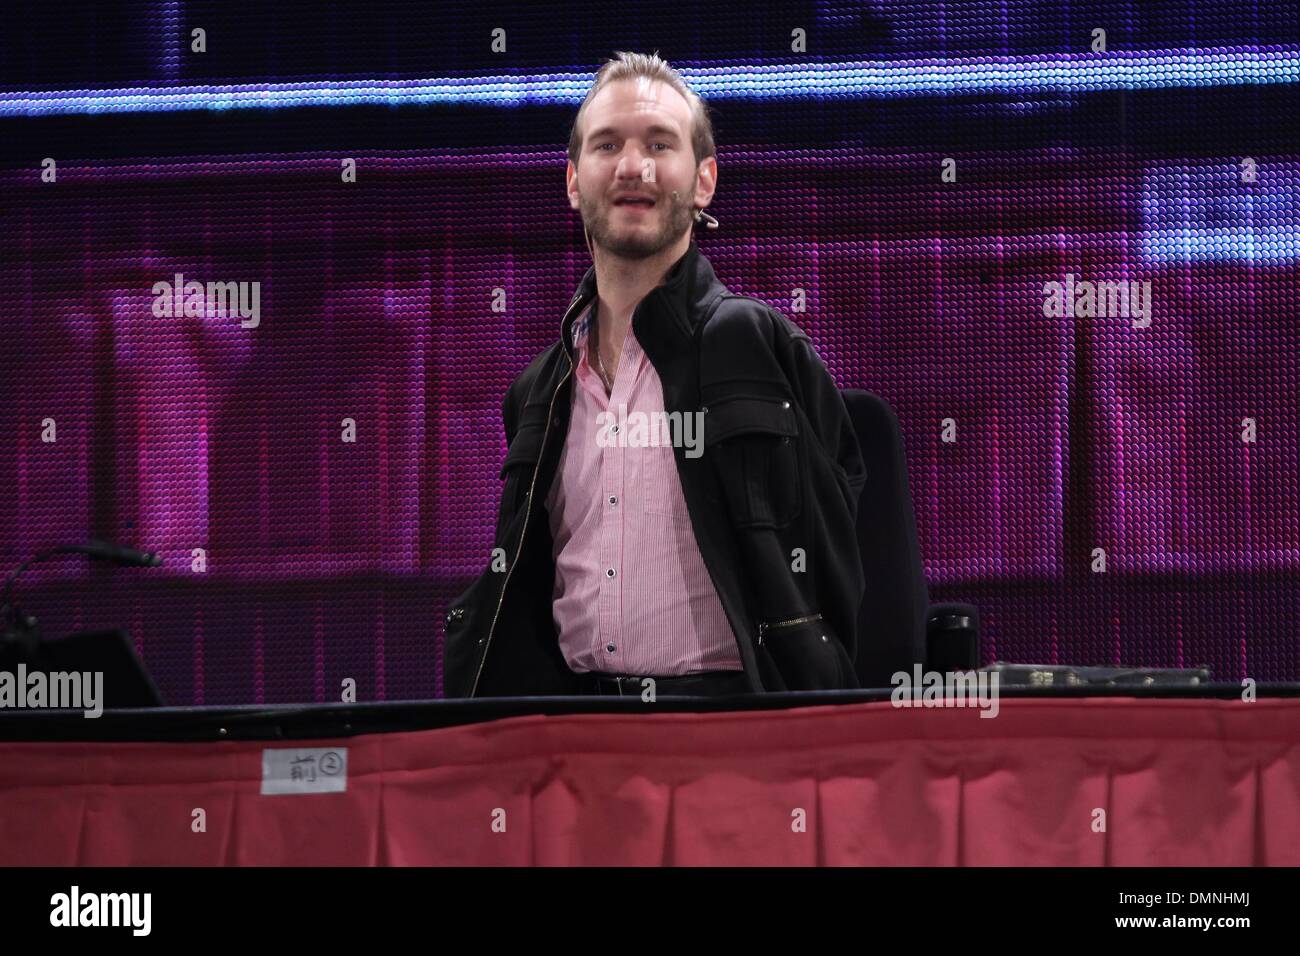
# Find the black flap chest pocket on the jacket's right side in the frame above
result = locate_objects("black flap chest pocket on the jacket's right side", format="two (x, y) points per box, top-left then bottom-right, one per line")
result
(705, 398), (803, 528)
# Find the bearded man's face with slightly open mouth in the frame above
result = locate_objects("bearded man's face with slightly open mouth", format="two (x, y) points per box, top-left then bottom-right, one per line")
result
(568, 77), (716, 259)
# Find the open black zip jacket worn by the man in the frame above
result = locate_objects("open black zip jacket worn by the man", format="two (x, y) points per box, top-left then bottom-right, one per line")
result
(443, 242), (866, 697)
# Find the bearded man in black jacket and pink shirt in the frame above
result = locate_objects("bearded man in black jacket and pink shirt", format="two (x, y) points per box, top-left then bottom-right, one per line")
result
(445, 53), (866, 697)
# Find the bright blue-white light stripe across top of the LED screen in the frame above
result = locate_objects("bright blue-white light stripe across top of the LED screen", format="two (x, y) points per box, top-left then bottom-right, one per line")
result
(0, 47), (1300, 116)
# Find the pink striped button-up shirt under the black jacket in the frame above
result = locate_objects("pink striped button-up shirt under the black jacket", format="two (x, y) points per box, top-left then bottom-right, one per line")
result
(546, 304), (744, 676)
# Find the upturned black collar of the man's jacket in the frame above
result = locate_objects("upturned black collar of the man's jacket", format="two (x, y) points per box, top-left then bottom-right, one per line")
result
(560, 239), (723, 360)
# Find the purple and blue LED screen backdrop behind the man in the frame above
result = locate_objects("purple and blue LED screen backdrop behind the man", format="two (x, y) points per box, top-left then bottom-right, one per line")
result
(0, 0), (1300, 704)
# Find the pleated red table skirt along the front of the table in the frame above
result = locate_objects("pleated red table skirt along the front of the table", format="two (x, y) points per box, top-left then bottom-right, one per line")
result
(0, 698), (1300, 866)
